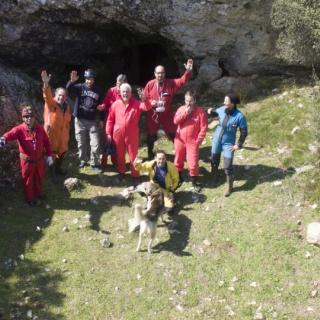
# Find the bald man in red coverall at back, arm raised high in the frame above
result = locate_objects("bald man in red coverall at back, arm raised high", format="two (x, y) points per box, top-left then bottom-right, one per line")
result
(144, 59), (193, 160)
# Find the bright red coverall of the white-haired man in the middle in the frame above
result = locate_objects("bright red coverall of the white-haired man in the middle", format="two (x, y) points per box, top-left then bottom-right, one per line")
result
(106, 97), (151, 177)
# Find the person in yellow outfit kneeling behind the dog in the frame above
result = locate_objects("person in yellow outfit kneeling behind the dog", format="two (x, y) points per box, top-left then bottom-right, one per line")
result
(134, 150), (179, 214)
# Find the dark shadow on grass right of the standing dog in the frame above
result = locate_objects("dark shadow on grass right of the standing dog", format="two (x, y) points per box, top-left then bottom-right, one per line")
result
(154, 214), (192, 256)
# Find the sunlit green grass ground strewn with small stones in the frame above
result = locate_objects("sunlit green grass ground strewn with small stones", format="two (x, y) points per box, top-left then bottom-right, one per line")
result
(0, 84), (320, 320)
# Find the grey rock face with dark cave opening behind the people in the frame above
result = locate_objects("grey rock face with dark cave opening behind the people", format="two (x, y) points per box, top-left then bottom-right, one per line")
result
(0, 0), (304, 99)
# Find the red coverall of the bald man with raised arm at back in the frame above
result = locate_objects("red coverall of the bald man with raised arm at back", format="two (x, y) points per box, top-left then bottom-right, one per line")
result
(144, 71), (192, 135)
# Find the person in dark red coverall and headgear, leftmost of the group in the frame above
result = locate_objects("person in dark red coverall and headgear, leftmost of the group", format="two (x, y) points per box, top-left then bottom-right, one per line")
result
(0, 105), (53, 206)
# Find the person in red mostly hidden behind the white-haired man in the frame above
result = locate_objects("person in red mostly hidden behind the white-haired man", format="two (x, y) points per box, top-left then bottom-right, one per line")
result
(97, 74), (127, 166)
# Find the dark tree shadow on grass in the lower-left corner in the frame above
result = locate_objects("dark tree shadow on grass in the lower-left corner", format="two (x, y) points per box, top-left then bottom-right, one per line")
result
(0, 189), (64, 320)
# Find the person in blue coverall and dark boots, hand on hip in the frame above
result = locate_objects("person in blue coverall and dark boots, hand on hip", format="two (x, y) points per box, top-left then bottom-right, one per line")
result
(207, 94), (248, 197)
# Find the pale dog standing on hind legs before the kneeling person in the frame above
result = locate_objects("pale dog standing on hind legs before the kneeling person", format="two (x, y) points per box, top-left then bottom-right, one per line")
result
(129, 181), (164, 253)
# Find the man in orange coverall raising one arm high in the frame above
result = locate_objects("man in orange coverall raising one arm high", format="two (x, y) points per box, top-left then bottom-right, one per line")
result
(41, 70), (71, 181)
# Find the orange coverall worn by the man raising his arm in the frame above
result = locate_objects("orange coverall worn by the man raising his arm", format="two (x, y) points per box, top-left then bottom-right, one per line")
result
(43, 86), (71, 158)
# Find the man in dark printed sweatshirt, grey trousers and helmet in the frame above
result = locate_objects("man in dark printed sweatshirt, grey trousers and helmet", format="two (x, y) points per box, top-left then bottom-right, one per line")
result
(66, 69), (103, 173)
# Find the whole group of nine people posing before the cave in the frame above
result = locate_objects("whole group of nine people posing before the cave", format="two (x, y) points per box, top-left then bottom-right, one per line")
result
(0, 59), (247, 211)
